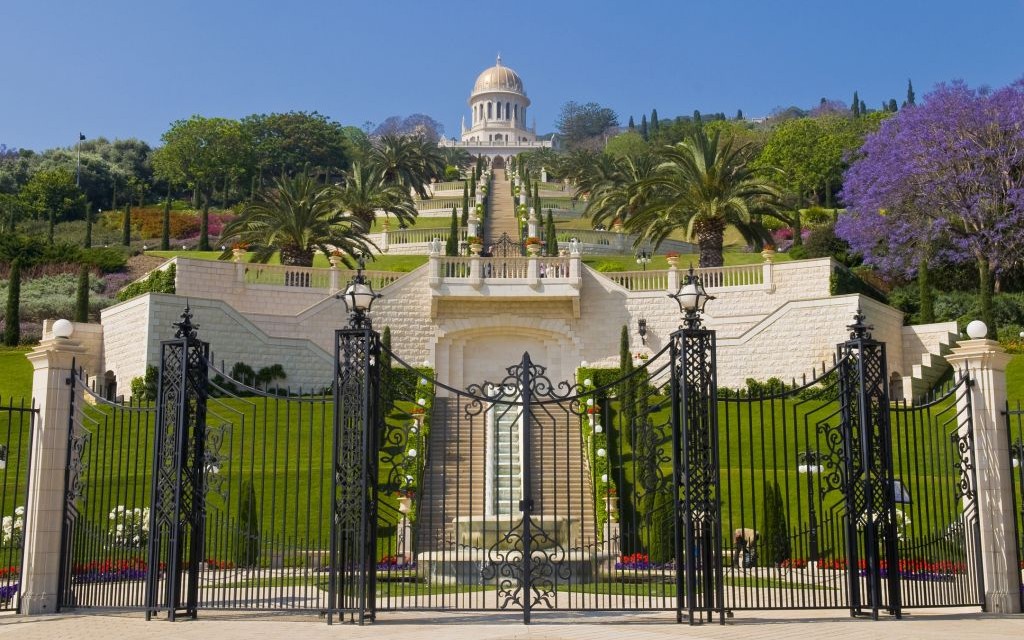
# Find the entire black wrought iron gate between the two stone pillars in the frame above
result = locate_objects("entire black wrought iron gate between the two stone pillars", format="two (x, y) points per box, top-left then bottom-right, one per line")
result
(54, 308), (982, 624)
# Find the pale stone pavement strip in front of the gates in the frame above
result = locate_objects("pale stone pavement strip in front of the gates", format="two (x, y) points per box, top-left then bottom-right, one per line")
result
(0, 609), (1024, 640)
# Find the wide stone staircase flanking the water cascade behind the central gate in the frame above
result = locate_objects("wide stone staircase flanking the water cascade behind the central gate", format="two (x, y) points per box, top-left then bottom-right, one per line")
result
(415, 397), (596, 553)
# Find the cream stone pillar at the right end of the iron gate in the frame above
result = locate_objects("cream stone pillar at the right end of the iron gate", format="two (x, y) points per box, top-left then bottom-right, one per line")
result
(946, 323), (1021, 613)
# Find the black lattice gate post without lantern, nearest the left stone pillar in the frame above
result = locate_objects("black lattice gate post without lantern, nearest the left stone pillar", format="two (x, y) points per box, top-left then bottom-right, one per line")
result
(145, 304), (210, 621)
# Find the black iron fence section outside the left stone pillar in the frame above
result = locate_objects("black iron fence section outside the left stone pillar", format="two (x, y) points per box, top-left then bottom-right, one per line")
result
(0, 398), (39, 611)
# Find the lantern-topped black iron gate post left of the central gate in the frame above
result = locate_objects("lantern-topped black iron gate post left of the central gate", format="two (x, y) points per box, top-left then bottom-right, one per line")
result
(327, 258), (384, 625)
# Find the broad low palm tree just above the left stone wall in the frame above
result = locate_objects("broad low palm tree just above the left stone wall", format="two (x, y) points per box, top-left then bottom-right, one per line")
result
(220, 173), (376, 266)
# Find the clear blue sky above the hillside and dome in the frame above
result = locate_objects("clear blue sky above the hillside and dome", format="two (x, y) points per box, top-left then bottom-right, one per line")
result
(0, 0), (1024, 150)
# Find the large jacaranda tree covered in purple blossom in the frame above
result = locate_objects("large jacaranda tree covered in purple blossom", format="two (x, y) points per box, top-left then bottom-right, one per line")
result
(837, 80), (1024, 337)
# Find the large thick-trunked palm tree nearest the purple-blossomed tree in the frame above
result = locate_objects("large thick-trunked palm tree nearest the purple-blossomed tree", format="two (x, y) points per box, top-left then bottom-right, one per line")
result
(626, 130), (780, 266)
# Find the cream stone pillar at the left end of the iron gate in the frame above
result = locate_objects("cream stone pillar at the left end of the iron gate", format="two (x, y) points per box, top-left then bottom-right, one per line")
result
(22, 331), (86, 614)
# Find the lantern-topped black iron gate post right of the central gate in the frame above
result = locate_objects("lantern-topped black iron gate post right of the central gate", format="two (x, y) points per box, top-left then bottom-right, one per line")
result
(669, 267), (725, 625)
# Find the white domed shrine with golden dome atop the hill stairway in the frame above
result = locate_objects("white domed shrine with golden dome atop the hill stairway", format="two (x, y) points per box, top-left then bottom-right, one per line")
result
(439, 55), (551, 169)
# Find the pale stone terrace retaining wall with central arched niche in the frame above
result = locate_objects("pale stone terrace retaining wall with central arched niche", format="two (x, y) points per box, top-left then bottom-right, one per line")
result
(103, 258), (948, 395)
